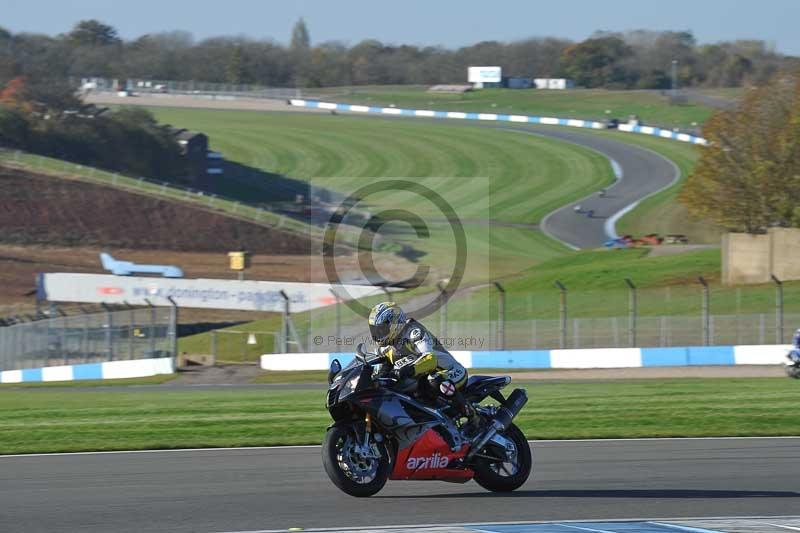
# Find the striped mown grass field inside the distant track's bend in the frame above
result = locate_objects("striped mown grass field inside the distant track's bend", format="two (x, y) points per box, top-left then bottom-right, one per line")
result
(151, 108), (613, 223)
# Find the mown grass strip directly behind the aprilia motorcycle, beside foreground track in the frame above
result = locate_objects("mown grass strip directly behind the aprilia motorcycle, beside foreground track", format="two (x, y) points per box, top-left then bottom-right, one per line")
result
(0, 378), (800, 453)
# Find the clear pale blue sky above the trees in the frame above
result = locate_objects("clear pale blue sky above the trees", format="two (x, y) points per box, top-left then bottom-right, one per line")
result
(0, 0), (800, 55)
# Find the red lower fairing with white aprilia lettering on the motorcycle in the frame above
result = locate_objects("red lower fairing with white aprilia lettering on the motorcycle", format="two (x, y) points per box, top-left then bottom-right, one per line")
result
(389, 429), (474, 483)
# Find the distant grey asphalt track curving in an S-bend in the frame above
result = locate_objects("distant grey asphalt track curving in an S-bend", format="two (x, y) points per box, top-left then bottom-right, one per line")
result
(503, 127), (680, 248)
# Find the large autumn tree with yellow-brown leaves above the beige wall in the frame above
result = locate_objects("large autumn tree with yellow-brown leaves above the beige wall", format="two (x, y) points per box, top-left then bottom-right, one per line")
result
(680, 71), (800, 233)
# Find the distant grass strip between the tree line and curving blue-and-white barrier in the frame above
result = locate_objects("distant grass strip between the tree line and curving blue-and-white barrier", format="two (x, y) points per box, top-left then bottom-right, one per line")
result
(322, 88), (714, 128)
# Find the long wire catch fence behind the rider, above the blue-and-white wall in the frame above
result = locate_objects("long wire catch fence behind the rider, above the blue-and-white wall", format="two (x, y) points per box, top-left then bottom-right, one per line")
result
(239, 280), (800, 359)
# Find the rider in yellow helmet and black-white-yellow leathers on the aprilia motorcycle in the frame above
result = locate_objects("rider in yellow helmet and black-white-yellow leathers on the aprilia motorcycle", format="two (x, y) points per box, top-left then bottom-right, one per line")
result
(369, 302), (475, 426)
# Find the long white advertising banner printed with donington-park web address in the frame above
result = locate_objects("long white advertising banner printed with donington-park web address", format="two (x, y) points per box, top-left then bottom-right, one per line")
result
(40, 273), (392, 313)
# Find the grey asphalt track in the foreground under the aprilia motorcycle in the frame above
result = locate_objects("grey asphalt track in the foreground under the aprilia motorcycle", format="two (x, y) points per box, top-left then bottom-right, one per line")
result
(0, 438), (800, 532)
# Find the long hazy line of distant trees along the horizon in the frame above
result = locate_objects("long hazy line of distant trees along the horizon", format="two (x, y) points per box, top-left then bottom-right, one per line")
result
(0, 19), (800, 89)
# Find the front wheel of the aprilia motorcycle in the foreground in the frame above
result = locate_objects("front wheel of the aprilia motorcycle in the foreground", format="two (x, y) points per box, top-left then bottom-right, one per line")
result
(322, 426), (391, 498)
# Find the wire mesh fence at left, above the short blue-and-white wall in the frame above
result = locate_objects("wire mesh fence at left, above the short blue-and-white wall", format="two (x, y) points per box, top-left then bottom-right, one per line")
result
(0, 307), (177, 370)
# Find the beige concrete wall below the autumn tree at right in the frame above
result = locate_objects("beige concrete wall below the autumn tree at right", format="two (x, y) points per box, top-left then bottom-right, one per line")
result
(722, 228), (800, 285)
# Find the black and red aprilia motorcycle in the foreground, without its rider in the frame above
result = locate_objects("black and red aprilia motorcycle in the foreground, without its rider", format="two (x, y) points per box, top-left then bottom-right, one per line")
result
(322, 345), (533, 497)
